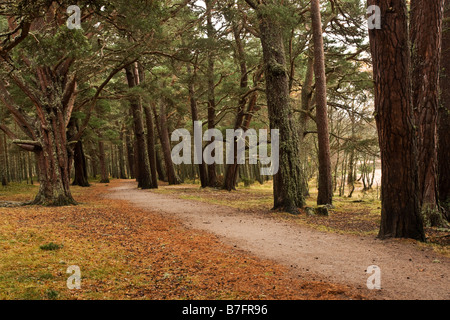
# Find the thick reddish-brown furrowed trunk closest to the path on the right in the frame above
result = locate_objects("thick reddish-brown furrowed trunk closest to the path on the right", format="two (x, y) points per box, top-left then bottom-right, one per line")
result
(368, 0), (425, 241)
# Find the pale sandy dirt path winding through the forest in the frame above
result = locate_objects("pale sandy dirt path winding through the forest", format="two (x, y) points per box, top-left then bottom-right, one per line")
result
(109, 181), (450, 300)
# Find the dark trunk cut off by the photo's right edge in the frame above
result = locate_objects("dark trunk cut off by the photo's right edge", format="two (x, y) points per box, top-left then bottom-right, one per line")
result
(438, 0), (450, 221)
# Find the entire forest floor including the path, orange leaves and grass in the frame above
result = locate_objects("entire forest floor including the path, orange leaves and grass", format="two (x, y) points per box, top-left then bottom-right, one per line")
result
(0, 180), (450, 300)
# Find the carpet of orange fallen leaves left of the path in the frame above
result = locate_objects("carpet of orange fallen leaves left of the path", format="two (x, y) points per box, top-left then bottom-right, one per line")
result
(0, 182), (370, 300)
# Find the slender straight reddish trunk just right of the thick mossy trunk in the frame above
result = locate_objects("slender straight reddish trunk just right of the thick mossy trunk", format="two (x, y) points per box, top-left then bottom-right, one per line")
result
(311, 0), (333, 205)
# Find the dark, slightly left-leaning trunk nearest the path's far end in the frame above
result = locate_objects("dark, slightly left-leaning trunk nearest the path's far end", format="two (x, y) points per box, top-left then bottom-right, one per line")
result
(125, 64), (152, 189)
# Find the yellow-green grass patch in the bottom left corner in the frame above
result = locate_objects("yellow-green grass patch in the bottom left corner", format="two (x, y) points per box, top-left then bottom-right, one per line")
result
(0, 225), (134, 300)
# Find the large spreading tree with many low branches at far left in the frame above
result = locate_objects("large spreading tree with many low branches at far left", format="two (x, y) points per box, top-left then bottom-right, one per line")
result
(0, 1), (148, 205)
